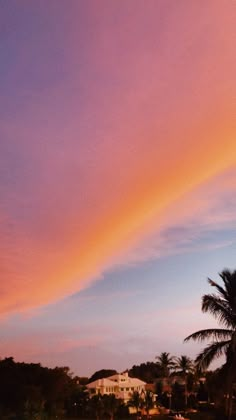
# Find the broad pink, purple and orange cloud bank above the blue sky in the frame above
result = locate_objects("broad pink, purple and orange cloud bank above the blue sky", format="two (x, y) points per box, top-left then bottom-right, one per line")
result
(0, 0), (236, 374)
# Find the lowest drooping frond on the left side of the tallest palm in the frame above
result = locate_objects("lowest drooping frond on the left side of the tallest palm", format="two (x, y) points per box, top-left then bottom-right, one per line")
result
(195, 340), (231, 370)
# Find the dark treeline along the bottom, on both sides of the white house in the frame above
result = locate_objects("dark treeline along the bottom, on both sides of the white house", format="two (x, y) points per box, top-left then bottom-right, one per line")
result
(0, 353), (230, 420)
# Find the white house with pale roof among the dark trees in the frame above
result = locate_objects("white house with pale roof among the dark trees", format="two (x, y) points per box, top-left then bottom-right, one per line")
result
(87, 372), (146, 402)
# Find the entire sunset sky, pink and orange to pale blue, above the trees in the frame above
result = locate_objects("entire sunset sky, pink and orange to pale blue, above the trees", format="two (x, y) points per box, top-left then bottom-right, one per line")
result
(0, 0), (236, 376)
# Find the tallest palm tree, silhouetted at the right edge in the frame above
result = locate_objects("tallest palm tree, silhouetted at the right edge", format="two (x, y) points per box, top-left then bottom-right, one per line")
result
(184, 270), (236, 420)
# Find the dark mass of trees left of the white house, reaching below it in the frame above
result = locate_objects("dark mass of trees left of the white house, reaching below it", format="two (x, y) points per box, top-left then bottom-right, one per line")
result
(0, 357), (129, 420)
